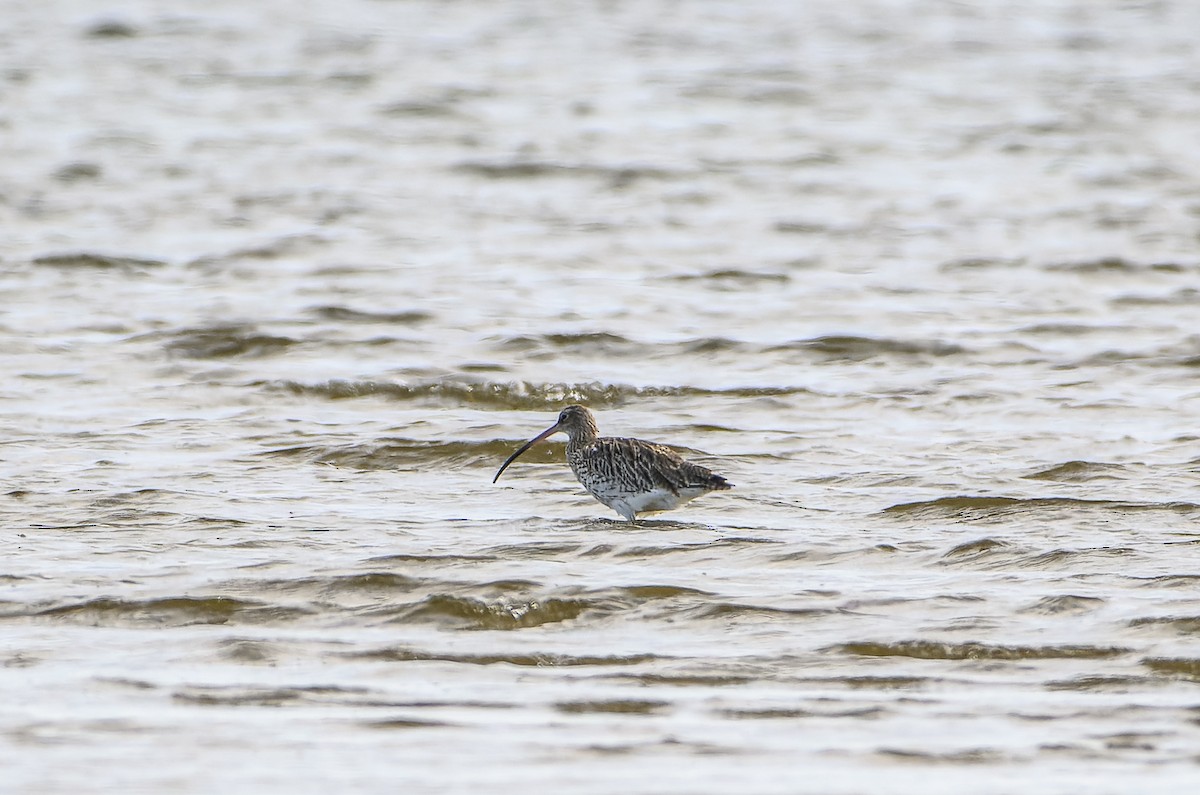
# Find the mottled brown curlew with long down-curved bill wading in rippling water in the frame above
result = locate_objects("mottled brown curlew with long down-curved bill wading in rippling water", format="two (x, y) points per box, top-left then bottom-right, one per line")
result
(492, 406), (733, 521)
